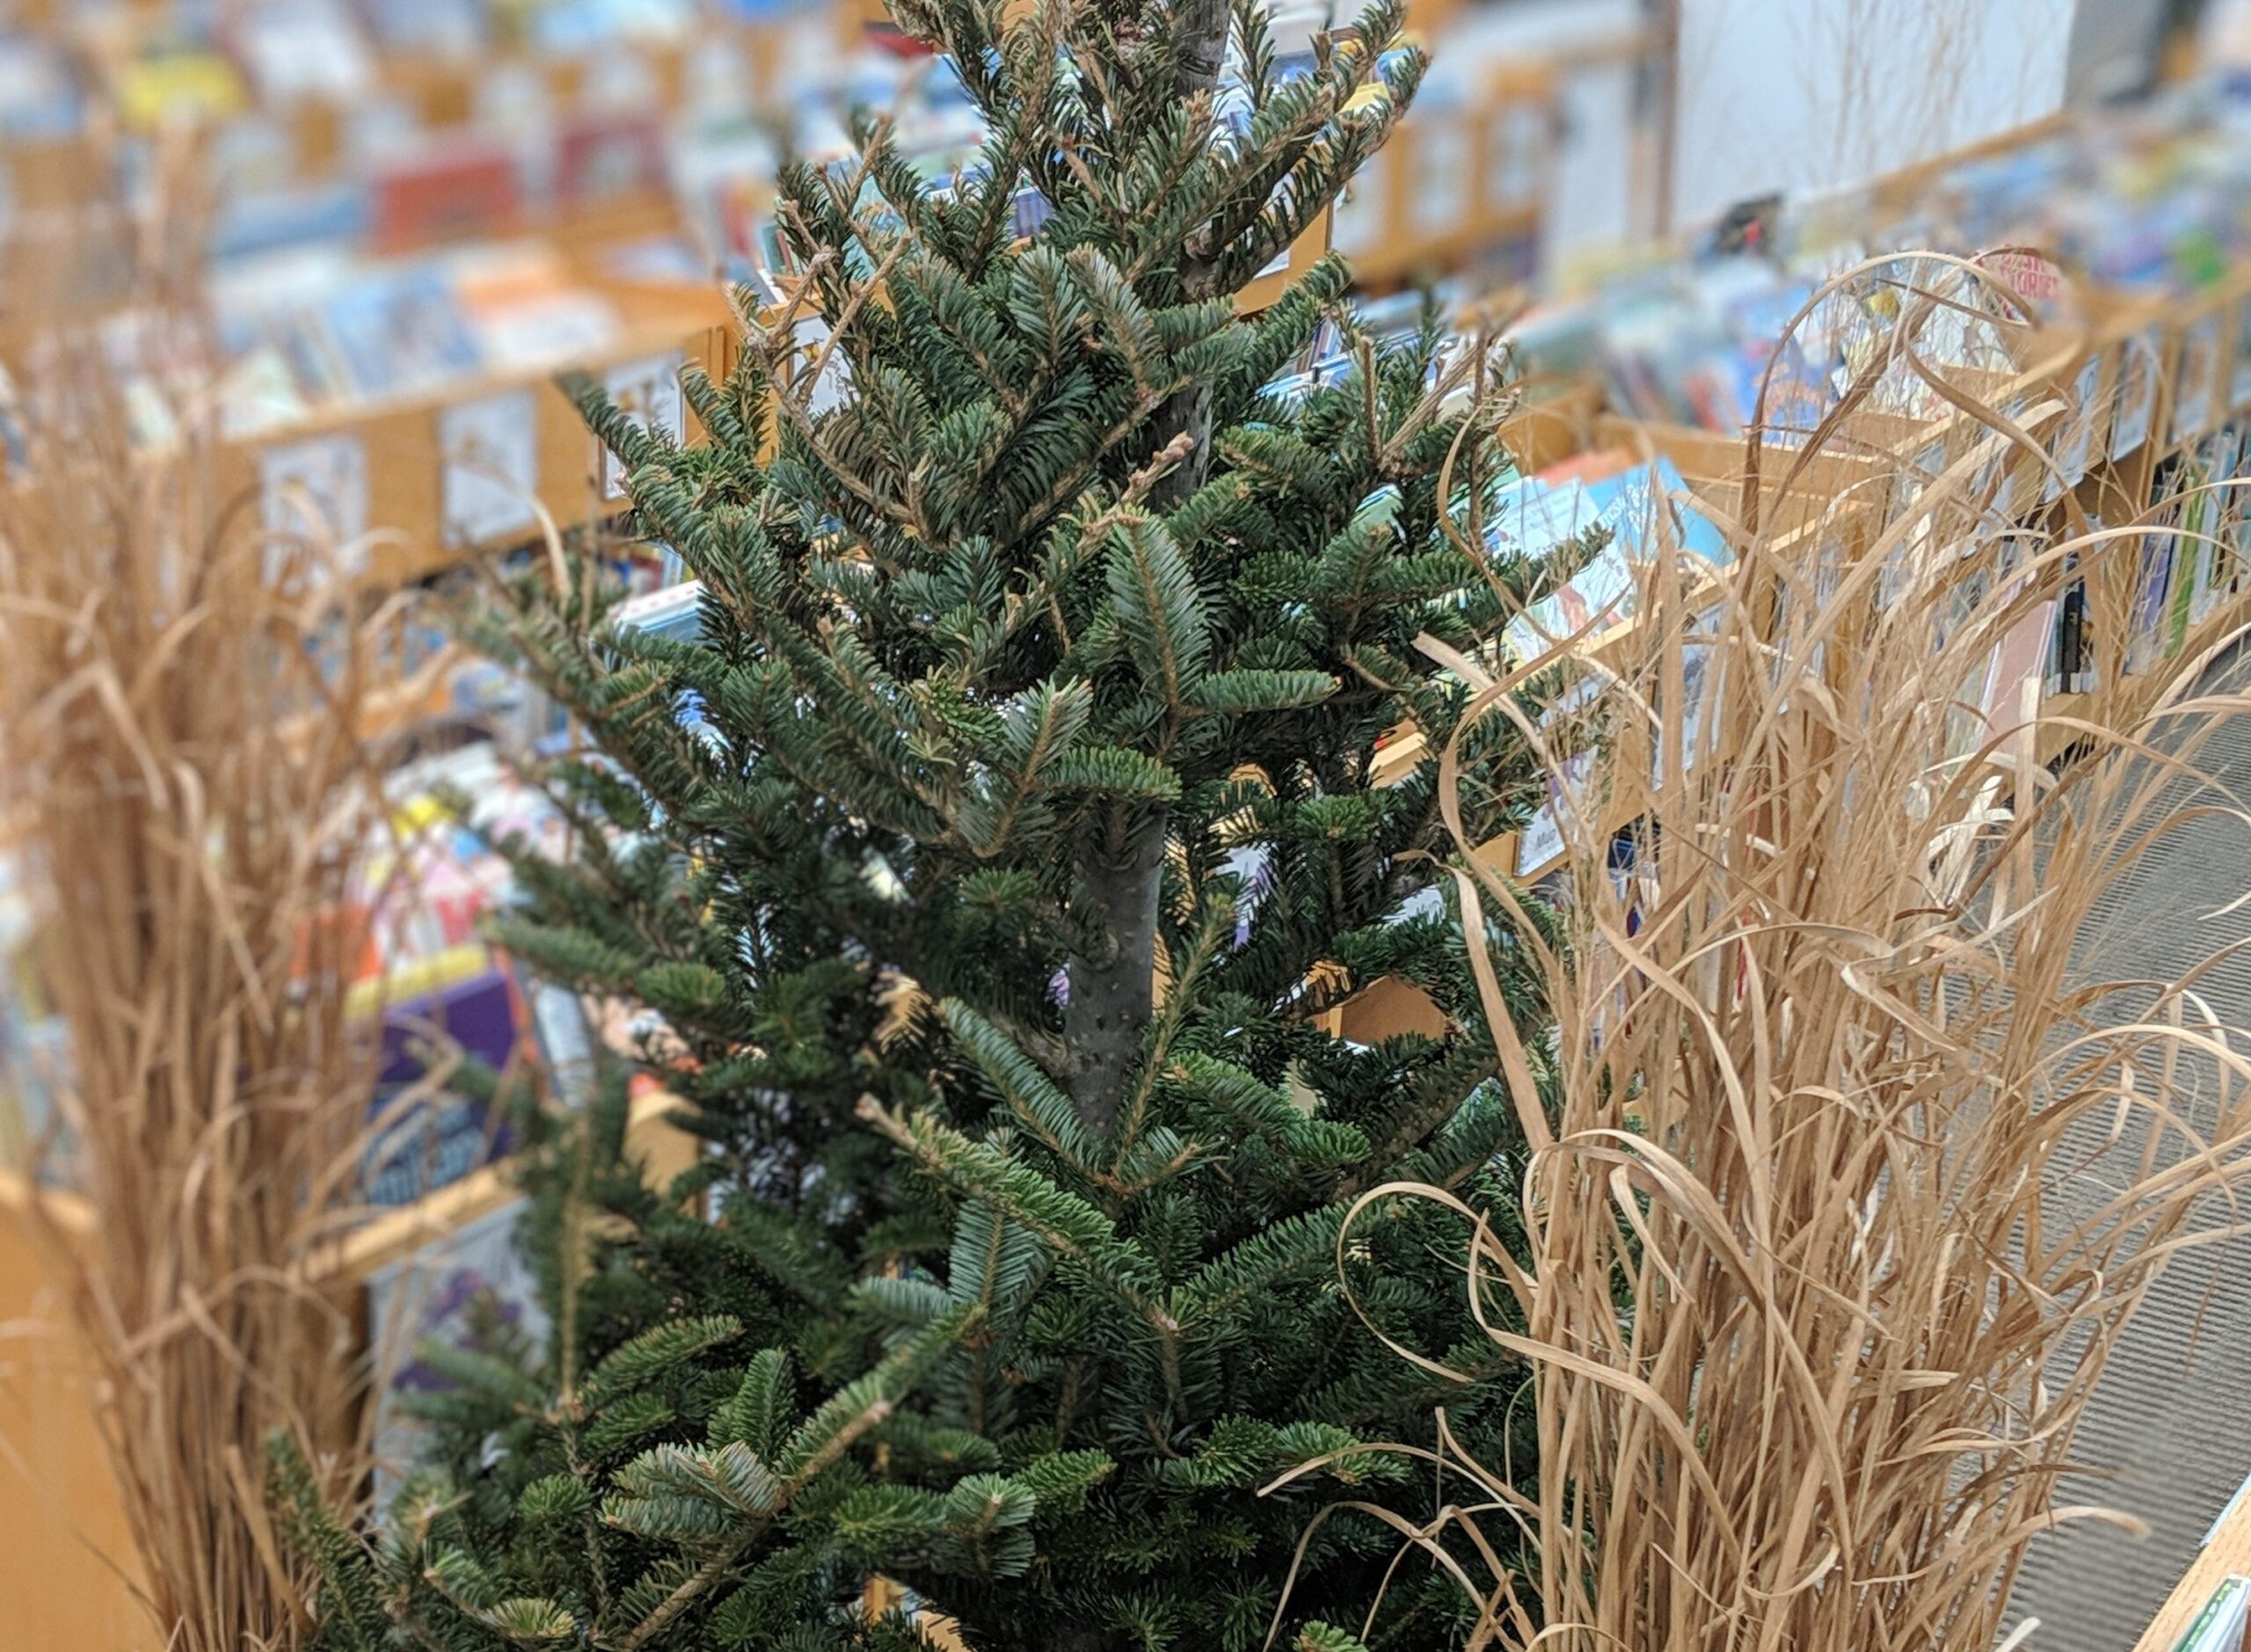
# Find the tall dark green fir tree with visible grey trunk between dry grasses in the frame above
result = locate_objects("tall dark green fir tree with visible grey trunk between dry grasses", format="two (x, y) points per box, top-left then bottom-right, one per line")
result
(290, 0), (1566, 1652)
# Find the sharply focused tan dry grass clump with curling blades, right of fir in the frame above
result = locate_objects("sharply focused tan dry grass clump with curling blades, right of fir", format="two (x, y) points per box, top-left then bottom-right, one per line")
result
(1315, 251), (2251, 1652)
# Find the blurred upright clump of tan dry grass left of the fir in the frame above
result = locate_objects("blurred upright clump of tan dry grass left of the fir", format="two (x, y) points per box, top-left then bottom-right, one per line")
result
(0, 326), (396, 1652)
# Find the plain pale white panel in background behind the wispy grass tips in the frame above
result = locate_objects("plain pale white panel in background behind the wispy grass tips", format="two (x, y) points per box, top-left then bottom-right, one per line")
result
(1672, 0), (2071, 225)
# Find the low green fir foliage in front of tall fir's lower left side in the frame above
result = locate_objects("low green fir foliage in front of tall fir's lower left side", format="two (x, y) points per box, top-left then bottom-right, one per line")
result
(268, 1087), (1110, 1652)
